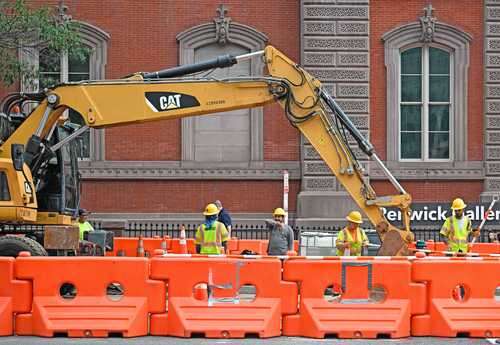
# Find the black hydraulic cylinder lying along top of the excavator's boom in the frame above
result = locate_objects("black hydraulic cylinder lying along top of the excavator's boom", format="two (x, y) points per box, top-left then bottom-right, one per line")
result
(142, 54), (238, 79)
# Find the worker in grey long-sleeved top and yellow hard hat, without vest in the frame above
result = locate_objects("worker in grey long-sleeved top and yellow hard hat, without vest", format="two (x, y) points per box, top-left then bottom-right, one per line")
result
(266, 207), (294, 255)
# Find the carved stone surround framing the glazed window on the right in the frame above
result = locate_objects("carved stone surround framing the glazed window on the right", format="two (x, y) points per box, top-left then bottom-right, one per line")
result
(382, 22), (472, 169)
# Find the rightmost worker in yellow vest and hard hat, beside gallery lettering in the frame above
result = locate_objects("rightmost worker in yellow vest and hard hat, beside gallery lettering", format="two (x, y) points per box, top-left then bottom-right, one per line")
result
(440, 198), (479, 253)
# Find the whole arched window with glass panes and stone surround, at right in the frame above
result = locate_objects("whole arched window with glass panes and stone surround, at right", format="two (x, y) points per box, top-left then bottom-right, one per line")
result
(382, 22), (472, 164)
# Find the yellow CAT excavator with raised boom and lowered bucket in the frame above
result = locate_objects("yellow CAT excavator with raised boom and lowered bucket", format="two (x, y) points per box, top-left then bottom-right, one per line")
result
(0, 46), (414, 255)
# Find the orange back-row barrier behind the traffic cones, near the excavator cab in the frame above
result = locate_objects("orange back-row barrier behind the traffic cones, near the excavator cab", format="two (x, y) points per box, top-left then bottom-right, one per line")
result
(106, 237), (196, 257)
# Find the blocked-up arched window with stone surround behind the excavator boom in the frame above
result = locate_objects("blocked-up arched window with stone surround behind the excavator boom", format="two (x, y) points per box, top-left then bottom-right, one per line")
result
(177, 18), (267, 167)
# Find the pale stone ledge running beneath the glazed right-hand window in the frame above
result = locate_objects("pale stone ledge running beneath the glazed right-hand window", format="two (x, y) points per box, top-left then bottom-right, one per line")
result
(369, 161), (485, 180)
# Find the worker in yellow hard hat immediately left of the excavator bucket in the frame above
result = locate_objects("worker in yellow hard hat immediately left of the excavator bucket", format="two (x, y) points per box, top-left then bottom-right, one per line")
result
(336, 211), (369, 256)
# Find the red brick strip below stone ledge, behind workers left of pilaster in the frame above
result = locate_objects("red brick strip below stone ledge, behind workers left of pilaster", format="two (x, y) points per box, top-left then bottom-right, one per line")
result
(82, 180), (300, 213)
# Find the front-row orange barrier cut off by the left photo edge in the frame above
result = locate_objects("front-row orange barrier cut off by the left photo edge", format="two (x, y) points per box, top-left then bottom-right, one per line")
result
(0, 257), (31, 336)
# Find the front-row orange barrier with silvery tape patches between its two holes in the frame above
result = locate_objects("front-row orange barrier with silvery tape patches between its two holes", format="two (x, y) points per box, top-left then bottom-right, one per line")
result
(151, 256), (297, 338)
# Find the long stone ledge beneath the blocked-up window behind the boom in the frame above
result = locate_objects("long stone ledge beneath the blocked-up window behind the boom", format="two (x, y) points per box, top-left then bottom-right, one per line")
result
(79, 161), (300, 180)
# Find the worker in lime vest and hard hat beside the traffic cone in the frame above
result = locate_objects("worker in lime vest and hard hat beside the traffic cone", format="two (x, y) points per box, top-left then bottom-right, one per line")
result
(195, 204), (229, 254)
